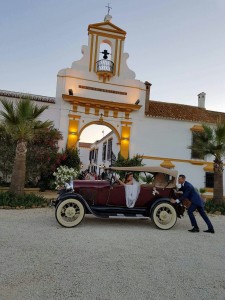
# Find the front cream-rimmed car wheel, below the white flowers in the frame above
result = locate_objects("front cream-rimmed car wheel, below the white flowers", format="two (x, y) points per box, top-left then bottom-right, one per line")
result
(55, 199), (85, 227)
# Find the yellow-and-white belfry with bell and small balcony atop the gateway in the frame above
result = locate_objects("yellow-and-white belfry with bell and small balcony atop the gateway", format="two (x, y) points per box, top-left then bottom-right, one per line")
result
(88, 14), (126, 82)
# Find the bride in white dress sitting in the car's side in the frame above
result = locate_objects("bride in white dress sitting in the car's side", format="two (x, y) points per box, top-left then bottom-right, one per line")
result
(118, 173), (140, 208)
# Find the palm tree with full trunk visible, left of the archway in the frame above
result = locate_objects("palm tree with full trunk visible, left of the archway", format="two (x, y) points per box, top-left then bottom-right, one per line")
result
(0, 98), (52, 194)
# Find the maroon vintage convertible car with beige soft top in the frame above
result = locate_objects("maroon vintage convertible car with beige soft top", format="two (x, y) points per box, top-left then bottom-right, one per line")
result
(52, 166), (185, 229)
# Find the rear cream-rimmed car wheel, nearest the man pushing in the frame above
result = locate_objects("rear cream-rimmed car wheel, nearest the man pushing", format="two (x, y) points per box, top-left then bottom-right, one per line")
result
(152, 202), (177, 230)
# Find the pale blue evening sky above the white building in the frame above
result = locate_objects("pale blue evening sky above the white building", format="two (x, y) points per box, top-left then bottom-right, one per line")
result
(0, 0), (225, 142)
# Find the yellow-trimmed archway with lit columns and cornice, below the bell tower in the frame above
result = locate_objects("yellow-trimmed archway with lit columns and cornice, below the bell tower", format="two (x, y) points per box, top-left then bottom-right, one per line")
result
(63, 94), (141, 158)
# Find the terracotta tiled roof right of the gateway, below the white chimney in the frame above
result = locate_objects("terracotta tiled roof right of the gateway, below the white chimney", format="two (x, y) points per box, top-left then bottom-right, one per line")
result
(146, 100), (225, 123)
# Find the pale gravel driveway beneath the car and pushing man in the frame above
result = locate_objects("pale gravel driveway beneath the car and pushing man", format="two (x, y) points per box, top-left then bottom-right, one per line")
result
(0, 208), (225, 300)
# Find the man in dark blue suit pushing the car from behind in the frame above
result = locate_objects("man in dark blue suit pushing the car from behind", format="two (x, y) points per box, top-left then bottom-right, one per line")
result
(172, 175), (215, 233)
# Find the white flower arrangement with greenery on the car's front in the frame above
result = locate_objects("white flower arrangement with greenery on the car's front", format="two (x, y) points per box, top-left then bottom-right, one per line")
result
(53, 166), (79, 190)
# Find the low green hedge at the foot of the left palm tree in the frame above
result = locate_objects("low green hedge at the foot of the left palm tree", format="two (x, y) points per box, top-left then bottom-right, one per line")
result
(0, 192), (48, 208)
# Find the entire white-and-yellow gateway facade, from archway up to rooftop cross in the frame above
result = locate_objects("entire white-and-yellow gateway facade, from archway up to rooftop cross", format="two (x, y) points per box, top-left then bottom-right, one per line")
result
(56, 10), (146, 158)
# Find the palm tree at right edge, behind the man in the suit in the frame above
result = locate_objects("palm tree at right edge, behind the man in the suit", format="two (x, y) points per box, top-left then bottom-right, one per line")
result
(188, 121), (225, 204)
